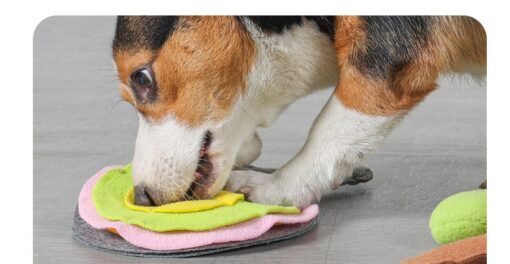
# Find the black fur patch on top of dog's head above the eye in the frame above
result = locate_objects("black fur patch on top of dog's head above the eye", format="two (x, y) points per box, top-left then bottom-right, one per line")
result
(112, 16), (179, 50)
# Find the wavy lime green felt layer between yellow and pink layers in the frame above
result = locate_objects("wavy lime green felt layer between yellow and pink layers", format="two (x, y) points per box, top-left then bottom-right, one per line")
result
(92, 165), (299, 232)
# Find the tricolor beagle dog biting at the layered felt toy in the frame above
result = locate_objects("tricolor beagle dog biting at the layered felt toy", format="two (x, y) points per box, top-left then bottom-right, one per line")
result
(112, 16), (486, 207)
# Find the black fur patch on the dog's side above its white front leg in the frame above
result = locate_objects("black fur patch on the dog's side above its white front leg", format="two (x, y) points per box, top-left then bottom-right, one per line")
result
(350, 16), (431, 79)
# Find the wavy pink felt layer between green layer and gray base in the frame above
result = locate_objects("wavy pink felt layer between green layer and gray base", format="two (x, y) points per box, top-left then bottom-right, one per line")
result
(78, 166), (319, 250)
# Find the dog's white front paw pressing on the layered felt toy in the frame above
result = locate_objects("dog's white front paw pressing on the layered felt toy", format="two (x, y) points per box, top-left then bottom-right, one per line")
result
(226, 170), (320, 208)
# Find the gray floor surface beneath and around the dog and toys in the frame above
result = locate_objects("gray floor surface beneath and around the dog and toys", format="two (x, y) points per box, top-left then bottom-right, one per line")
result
(34, 17), (486, 263)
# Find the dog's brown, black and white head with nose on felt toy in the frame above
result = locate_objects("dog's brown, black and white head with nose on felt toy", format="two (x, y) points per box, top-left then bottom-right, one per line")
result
(113, 17), (256, 205)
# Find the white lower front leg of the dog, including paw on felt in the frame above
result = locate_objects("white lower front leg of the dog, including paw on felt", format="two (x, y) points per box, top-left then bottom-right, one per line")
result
(227, 95), (401, 207)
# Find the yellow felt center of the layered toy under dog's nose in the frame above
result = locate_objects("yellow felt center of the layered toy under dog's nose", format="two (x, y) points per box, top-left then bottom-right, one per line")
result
(124, 189), (244, 213)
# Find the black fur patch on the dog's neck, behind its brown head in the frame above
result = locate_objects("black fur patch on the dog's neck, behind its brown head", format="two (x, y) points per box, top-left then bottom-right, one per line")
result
(242, 16), (335, 39)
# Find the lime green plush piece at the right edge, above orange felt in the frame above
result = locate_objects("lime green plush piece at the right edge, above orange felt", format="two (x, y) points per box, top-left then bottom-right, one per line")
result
(429, 190), (487, 244)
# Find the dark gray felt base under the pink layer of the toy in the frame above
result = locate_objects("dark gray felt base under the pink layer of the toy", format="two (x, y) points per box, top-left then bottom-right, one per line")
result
(73, 208), (318, 258)
